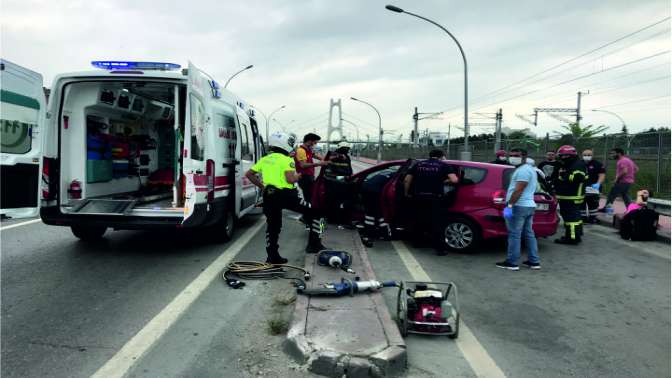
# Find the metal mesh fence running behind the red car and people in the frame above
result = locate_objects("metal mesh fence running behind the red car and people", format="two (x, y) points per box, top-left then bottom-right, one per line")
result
(356, 130), (671, 199)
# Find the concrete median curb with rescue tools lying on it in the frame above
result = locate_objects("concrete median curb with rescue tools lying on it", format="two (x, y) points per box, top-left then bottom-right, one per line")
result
(284, 230), (406, 377)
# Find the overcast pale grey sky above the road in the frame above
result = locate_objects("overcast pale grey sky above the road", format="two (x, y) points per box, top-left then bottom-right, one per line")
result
(1, 0), (671, 139)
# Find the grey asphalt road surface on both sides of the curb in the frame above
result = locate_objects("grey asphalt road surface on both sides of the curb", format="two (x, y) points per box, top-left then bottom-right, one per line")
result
(0, 160), (670, 377)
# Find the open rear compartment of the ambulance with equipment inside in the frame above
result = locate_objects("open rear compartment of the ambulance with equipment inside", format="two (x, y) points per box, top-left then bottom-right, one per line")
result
(60, 81), (184, 217)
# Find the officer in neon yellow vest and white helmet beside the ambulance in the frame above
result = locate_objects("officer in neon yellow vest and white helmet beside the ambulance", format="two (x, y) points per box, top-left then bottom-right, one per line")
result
(245, 132), (326, 264)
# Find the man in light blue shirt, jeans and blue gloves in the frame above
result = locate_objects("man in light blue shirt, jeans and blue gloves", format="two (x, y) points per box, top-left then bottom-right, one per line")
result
(496, 148), (541, 270)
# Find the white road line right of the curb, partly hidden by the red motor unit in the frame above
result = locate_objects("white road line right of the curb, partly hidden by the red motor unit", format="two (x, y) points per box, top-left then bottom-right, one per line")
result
(392, 241), (506, 377)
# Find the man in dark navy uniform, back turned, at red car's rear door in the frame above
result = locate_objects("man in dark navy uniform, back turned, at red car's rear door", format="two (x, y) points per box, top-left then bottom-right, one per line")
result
(404, 150), (459, 255)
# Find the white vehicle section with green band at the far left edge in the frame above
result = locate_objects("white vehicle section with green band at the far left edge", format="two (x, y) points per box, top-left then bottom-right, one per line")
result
(0, 59), (46, 218)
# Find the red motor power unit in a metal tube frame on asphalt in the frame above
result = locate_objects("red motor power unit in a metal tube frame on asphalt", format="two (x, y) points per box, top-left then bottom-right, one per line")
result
(397, 281), (460, 339)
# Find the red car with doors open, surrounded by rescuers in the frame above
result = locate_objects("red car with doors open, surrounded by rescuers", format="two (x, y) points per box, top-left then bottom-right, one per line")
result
(314, 159), (559, 251)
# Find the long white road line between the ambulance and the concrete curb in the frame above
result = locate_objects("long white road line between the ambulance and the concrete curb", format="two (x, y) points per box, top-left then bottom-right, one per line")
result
(92, 219), (264, 378)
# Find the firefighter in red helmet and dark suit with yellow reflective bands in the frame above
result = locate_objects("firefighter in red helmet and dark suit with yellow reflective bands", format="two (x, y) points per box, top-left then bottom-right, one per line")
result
(553, 146), (588, 244)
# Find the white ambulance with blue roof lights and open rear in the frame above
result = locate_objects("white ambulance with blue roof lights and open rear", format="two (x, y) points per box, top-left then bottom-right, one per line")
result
(40, 61), (263, 240)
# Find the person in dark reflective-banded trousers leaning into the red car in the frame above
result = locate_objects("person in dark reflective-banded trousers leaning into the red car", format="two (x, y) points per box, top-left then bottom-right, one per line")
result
(361, 169), (395, 248)
